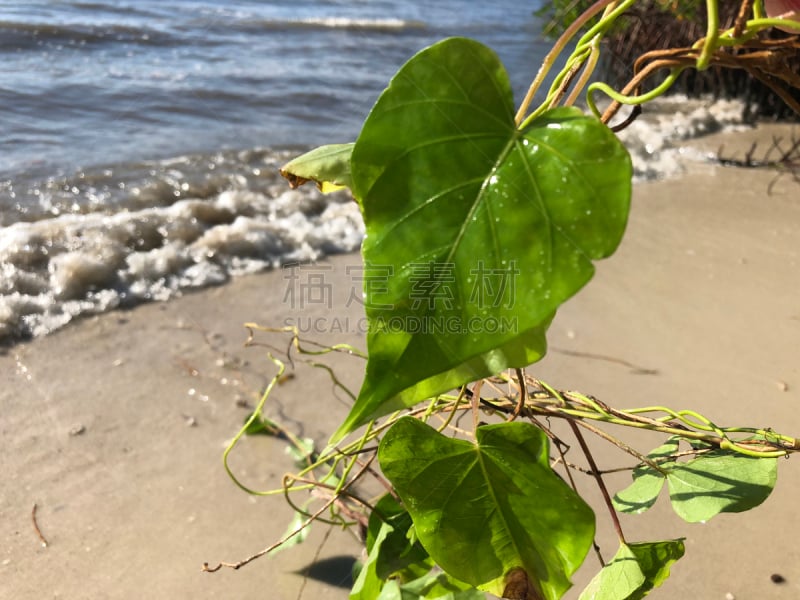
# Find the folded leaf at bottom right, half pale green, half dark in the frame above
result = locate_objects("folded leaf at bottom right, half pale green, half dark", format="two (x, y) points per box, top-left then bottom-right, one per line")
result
(579, 540), (685, 600)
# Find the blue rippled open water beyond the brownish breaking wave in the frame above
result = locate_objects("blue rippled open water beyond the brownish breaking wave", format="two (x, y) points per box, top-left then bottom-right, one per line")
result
(0, 0), (547, 183)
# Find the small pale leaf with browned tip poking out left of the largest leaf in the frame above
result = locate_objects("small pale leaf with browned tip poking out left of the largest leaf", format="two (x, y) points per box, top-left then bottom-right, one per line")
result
(280, 142), (354, 193)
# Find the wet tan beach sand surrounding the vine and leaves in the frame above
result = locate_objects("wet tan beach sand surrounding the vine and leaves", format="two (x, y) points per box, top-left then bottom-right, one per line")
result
(0, 127), (800, 600)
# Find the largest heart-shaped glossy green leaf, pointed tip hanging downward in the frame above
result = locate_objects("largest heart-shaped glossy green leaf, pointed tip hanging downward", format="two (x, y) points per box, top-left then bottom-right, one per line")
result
(334, 38), (631, 438)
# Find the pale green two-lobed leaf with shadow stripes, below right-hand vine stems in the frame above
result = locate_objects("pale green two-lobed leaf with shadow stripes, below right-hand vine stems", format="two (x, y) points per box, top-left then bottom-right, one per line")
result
(614, 439), (778, 523)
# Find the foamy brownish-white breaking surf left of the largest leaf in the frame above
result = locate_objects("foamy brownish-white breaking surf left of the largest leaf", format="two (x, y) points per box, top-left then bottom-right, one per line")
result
(0, 179), (364, 341)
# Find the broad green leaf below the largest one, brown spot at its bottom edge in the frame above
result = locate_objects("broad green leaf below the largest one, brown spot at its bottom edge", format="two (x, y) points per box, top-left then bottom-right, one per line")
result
(378, 417), (594, 600)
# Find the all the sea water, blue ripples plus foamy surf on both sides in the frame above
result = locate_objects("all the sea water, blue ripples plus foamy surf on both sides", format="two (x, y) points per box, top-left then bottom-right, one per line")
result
(0, 0), (752, 343)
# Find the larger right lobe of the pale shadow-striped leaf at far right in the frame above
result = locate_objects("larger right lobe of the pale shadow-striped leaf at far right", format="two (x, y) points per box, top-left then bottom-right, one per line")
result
(667, 451), (778, 523)
